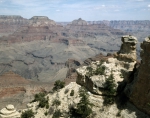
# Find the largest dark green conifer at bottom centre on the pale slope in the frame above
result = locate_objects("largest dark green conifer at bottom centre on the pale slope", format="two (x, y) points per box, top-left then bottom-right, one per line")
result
(70, 87), (93, 118)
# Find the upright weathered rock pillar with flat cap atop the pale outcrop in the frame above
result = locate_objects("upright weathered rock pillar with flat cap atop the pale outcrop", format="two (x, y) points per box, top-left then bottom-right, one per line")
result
(115, 35), (137, 62)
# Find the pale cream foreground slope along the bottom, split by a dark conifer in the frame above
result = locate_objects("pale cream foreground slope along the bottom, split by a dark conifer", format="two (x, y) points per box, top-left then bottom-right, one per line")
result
(19, 82), (148, 118)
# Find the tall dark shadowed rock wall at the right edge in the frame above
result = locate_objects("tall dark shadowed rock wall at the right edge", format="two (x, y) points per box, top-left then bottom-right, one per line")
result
(130, 37), (150, 114)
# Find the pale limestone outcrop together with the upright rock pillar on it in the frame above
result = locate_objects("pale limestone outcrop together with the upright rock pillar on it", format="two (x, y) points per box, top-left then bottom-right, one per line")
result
(76, 36), (137, 95)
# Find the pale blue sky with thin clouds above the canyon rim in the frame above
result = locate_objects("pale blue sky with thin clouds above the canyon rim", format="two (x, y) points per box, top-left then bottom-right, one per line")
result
(0, 0), (150, 21)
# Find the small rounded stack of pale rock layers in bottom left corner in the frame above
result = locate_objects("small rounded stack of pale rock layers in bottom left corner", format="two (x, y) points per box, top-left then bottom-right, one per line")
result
(0, 104), (20, 118)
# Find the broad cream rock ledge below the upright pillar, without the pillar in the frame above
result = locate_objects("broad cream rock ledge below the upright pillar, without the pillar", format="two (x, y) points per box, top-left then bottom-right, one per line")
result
(76, 58), (135, 95)
